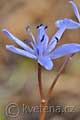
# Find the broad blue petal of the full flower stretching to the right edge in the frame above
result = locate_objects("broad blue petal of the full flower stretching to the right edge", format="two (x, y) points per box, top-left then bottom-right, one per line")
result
(49, 43), (80, 59)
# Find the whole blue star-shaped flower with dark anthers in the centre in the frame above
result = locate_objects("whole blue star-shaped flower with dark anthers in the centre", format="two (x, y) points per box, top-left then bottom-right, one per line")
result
(3, 25), (80, 70)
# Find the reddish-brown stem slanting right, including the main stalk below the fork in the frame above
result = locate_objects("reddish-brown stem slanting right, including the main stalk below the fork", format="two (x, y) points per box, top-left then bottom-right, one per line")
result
(39, 54), (74, 120)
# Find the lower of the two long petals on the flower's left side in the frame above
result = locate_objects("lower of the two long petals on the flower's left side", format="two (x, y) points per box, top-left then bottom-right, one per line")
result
(6, 45), (37, 60)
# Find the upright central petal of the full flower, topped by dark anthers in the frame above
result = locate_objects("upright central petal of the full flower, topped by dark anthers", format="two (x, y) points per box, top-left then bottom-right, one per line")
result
(36, 25), (49, 56)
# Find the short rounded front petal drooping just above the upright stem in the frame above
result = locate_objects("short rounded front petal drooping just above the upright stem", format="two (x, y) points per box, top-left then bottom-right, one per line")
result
(38, 56), (53, 70)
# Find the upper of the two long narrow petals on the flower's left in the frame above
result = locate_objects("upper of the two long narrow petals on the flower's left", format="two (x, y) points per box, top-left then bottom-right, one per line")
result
(2, 29), (34, 53)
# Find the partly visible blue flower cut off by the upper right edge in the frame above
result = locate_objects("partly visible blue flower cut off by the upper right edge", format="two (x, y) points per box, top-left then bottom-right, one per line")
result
(55, 1), (80, 29)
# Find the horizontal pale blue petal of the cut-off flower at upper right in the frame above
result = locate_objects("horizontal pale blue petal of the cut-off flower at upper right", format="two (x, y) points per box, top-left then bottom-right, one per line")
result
(55, 18), (80, 29)
